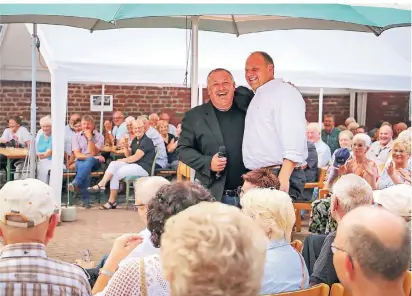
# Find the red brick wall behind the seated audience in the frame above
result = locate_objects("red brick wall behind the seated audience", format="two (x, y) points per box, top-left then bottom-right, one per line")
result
(0, 81), (409, 132)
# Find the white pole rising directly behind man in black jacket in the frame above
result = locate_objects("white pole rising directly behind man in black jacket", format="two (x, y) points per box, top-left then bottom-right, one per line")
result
(190, 16), (199, 108)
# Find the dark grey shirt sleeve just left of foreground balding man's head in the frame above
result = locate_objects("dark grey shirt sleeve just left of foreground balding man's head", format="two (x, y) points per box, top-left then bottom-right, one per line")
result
(310, 235), (339, 286)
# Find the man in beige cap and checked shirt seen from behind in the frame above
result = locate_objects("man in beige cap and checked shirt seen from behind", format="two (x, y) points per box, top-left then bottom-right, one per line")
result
(0, 179), (91, 296)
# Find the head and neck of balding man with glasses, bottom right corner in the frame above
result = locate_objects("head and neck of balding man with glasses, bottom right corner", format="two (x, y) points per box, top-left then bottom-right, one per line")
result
(331, 207), (411, 296)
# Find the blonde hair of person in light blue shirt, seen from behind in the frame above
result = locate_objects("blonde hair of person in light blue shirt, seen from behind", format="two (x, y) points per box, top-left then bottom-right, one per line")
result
(241, 188), (296, 242)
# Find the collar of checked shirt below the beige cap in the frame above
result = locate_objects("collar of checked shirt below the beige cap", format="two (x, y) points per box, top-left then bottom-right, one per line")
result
(0, 243), (47, 259)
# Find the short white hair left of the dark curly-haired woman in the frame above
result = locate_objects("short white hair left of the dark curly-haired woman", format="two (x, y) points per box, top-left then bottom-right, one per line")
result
(134, 176), (170, 205)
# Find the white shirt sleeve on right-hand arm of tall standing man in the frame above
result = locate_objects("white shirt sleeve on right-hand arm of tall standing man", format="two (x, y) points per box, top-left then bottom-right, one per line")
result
(274, 83), (308, 163)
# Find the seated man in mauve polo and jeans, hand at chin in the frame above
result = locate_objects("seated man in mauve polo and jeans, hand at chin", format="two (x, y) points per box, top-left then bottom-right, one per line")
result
(68, 115), (104, 209)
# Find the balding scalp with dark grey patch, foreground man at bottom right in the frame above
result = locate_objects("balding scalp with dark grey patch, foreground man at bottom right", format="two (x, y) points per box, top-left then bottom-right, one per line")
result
(334, 206), (411, 281)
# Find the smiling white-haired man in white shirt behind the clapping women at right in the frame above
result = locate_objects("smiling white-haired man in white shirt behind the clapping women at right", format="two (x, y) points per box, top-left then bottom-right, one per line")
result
(366, 125), (393, 170)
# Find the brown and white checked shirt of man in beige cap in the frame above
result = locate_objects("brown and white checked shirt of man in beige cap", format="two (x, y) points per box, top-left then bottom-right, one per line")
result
(0, 243), (91, 296)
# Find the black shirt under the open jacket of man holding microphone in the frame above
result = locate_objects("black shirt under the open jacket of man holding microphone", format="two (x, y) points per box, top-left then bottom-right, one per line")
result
(215, 104), (246, 190)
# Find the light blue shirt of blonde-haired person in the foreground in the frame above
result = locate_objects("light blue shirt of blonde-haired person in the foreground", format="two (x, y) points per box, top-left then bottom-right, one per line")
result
(260, 239), (309, 295)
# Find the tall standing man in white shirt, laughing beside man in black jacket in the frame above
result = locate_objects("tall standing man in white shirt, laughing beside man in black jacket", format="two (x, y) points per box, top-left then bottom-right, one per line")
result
(243, 52), (308, 200)
